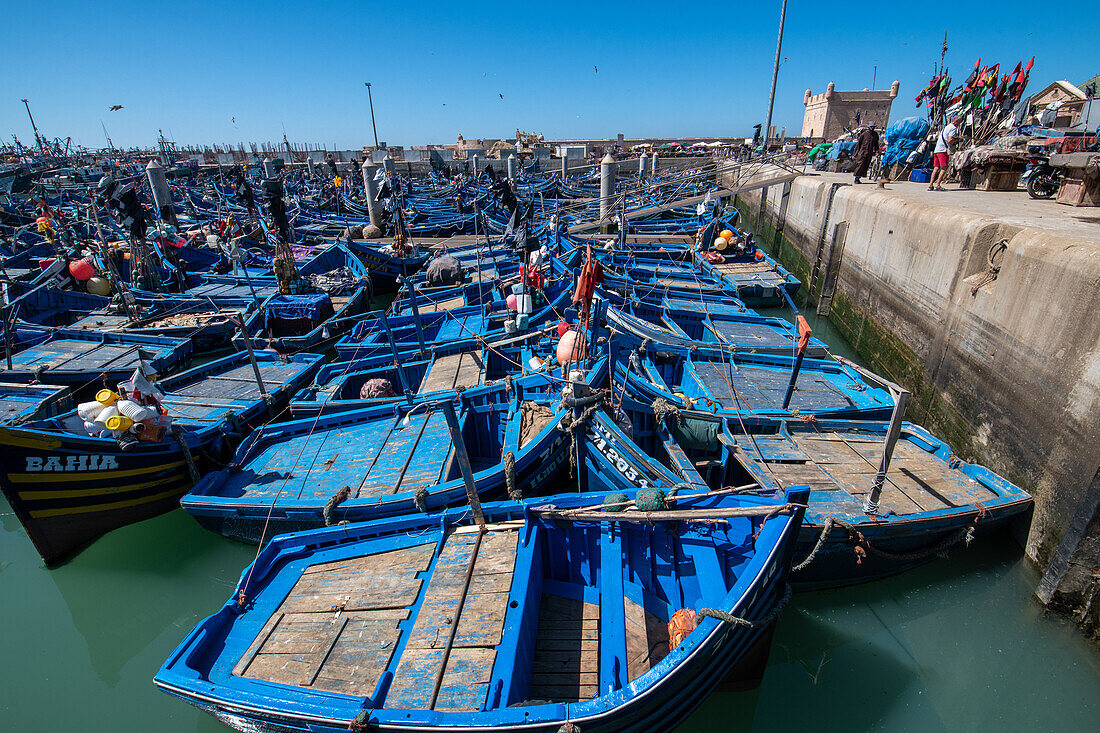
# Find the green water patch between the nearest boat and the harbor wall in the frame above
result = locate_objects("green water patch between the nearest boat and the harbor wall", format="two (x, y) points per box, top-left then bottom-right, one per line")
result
(680, 534), (1100, 733)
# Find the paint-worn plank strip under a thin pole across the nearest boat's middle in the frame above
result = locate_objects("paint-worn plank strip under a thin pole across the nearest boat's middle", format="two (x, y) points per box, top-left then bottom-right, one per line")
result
(386, 530), (518, 711)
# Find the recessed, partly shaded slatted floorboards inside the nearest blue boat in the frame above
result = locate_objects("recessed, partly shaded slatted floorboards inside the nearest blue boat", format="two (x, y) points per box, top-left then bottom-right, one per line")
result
(527, 593), (600, 702)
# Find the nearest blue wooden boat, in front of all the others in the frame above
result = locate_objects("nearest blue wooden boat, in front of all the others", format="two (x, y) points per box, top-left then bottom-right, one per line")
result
(154, 484), (806, 733)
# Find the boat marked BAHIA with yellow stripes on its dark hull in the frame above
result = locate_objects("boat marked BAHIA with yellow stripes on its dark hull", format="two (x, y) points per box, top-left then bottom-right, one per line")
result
(0, 352), (322, 564)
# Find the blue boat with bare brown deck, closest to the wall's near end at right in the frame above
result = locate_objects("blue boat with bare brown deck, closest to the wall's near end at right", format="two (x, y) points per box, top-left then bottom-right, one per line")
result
(611, 397), (1032, 590)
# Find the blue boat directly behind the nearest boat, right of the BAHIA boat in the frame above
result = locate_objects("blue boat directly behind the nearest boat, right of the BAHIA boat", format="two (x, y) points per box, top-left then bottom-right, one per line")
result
(180, 360), (606, 543)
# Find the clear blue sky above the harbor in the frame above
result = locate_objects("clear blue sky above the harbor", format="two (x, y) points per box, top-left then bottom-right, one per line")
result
(0, 0), (1100, 147)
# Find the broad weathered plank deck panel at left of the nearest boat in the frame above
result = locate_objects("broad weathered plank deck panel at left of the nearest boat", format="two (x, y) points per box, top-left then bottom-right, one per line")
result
(233, 543), (435, 696)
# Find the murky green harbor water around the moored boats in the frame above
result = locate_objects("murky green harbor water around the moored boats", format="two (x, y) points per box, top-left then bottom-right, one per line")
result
(0, 310), (1100, 733)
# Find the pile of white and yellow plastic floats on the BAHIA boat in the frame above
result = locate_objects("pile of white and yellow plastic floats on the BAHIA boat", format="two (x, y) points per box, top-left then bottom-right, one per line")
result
(66, 369), (172, 450)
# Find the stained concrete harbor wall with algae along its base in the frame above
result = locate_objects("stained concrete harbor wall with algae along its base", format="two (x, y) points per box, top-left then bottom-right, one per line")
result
(721, 165), (1100, 625)
